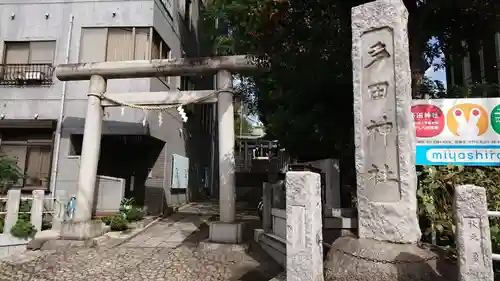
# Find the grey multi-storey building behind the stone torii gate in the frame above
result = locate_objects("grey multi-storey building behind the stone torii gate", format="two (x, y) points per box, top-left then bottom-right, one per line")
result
(0, 0), (215, 212)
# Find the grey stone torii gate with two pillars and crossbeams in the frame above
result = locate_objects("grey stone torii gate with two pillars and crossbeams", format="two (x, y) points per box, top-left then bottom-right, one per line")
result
(56, 55), (259, 243)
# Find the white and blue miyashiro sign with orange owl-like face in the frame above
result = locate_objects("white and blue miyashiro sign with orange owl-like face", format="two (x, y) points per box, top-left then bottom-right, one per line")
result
(411, 98), (500, 166)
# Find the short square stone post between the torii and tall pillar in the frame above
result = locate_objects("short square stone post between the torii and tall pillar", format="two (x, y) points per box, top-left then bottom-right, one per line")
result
(285, 172), (323, 281)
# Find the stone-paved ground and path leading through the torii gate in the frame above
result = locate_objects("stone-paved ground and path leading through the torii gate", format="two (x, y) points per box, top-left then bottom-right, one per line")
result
(0, 203), (283, 281)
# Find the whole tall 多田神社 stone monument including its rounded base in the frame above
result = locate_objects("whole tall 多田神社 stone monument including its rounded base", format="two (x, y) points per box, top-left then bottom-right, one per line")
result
(325, 0), (456, 281)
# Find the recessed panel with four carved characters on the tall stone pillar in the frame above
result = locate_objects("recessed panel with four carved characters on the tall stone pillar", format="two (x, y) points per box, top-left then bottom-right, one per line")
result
(361, 27), (401, 202)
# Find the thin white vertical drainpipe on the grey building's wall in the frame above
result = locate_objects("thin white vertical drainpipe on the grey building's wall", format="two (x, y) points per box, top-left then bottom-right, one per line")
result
(50, 15), (75, 196)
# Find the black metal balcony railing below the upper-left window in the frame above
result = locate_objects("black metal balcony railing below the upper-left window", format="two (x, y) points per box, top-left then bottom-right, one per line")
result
(0, 63), (54, 86)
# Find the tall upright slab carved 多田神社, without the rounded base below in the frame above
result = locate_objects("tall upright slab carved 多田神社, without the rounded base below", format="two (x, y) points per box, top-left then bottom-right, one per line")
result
(352, 0), (421, 243)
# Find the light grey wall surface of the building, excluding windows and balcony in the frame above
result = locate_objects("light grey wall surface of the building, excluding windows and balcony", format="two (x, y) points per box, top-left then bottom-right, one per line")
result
(0, 0), (209, 208)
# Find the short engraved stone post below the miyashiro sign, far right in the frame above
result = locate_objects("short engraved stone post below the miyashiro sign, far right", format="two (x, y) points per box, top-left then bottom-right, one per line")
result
(454, 185), (494, 281)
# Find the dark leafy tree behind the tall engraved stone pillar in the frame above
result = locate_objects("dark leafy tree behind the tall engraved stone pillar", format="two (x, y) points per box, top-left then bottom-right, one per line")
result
(201, 0), (500, 192)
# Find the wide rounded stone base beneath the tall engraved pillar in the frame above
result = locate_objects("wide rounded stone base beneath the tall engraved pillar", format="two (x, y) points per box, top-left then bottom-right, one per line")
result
(324, 237), (458, 281)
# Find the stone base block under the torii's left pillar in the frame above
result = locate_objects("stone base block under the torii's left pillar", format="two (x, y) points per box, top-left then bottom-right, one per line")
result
(60, 221), (109, 240)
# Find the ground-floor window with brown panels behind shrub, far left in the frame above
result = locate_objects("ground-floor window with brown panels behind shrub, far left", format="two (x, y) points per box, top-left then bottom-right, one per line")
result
(0, 129), (52, 190)
